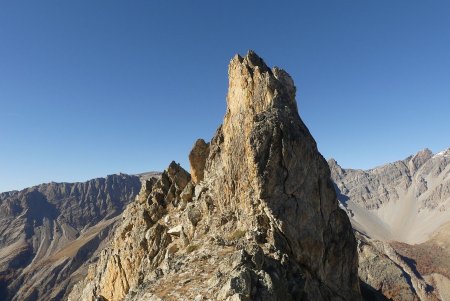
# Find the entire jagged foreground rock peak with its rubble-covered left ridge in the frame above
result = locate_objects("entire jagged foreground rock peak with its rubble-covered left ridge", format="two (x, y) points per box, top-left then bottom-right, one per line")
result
(69, 51), (361, 301)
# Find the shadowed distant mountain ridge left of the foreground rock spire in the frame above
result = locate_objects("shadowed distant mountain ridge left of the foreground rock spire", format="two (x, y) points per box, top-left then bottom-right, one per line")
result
(0, 175), (140, 301)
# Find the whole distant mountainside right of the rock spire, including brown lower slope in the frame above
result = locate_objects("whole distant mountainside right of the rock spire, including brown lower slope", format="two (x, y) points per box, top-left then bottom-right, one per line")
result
(328, 149), (450, 300)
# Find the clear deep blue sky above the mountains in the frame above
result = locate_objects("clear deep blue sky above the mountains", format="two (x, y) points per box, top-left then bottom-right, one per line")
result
(0, 0), (450, 191)
